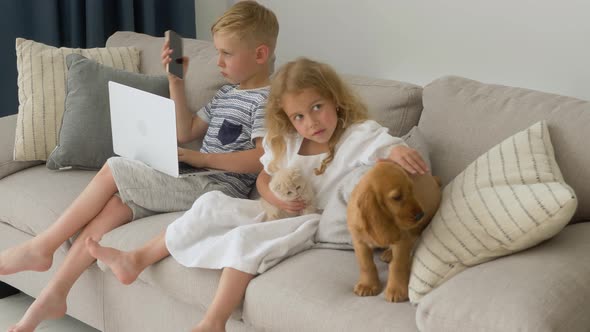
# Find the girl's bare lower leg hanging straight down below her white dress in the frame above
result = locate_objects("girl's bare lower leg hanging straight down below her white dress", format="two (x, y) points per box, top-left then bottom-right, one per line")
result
(192, 267), (254, 332)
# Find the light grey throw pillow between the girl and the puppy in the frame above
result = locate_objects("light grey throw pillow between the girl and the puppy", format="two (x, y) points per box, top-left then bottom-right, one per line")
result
(315, 127), (430, 249)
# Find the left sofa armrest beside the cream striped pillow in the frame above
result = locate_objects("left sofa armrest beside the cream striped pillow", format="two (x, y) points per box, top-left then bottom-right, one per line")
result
(0, 114), (43, 179)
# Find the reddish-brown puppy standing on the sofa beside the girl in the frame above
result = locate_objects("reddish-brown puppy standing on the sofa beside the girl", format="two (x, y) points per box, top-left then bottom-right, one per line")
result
(347, 161), (441, 302)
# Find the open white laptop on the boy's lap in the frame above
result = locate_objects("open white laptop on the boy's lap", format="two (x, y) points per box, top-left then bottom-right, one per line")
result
(109, 81), (224, 177)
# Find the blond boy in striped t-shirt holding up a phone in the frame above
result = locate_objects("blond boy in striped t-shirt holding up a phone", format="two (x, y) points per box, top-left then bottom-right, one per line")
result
(0, 1), (279, 331)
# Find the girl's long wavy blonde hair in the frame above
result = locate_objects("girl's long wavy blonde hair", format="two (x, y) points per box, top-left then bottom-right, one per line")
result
(266, 58), (368, 175)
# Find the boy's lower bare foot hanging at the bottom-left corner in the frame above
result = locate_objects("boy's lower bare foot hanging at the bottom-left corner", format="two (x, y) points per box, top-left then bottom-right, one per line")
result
(8, 293), (67, 332)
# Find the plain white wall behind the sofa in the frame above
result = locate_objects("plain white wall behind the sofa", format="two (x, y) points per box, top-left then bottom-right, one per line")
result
(197, 0), (590, 100)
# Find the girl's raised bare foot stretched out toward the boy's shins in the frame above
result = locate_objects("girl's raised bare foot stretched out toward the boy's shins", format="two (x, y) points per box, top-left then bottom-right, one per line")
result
(86, 238), (143, 285)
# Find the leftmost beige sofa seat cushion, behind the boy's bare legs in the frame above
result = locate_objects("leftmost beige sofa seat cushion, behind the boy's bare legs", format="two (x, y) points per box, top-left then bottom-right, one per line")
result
(0, 165), (96, 244)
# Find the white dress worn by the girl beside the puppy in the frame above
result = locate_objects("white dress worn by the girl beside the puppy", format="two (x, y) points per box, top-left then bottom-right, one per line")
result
(166, 120), (404, 274)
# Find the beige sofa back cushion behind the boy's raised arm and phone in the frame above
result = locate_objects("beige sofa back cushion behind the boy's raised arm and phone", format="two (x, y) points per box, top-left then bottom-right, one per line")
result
(106, 31), (227, 118)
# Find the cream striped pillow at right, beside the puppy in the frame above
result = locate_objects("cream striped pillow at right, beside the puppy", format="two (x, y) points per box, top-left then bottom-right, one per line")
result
(409, 121), (578, 303)
